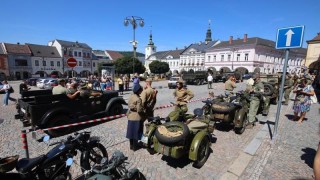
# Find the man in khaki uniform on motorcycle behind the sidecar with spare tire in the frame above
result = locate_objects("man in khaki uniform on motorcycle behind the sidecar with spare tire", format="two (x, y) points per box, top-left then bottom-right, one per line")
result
(168, 80), (194, 121)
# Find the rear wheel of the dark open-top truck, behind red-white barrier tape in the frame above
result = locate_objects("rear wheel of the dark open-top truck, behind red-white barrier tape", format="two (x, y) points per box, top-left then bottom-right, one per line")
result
(46, 114), (71, 137)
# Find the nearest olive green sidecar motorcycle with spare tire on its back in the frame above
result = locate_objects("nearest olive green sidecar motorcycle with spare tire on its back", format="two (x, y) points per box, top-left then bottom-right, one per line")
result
(145, 108), (214, 168)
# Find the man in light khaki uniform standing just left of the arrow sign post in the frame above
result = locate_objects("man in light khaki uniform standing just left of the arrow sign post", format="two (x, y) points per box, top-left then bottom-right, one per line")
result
(247, 74), (264, 129)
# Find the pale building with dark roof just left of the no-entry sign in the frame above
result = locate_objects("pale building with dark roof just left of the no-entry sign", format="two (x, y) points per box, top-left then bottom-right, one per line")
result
(27, 44), (63, 77)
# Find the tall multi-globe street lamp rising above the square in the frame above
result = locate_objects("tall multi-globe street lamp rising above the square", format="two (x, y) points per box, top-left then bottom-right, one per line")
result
(124, 16), (144, 73)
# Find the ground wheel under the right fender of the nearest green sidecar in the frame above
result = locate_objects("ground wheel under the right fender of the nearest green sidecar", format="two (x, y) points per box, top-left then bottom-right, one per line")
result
(193, 136), (210, 168)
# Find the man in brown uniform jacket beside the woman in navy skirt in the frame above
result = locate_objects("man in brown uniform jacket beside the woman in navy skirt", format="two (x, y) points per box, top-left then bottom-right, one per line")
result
(140, 78), (158, 120)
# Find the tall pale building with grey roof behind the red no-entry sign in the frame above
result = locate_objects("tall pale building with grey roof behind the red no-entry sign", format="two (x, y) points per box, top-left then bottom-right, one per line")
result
(48, 39), (93, 77)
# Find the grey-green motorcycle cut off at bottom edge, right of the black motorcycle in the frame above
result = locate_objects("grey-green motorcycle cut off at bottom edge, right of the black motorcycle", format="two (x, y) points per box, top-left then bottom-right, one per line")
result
(75, 150), (145, 180)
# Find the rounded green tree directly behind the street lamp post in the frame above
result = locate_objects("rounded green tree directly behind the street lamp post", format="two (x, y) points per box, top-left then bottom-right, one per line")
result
(114, 56), (146, 74)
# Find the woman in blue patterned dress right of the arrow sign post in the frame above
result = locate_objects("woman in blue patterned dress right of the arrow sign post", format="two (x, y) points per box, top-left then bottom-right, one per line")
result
(293, 79), (314, 123)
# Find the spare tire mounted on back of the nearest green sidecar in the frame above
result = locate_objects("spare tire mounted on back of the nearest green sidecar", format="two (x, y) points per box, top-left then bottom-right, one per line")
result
(155, 121), (189, 145)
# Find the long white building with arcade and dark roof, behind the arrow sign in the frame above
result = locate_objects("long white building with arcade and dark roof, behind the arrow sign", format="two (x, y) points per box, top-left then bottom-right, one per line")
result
(205, 34), (306, 74)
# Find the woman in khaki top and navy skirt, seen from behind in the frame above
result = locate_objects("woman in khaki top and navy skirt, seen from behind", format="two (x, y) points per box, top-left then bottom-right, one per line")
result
(126, 85), (145, 151)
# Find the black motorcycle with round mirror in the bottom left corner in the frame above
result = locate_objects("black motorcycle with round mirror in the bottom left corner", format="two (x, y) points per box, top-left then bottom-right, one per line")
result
(0, 132), (108, 180)
